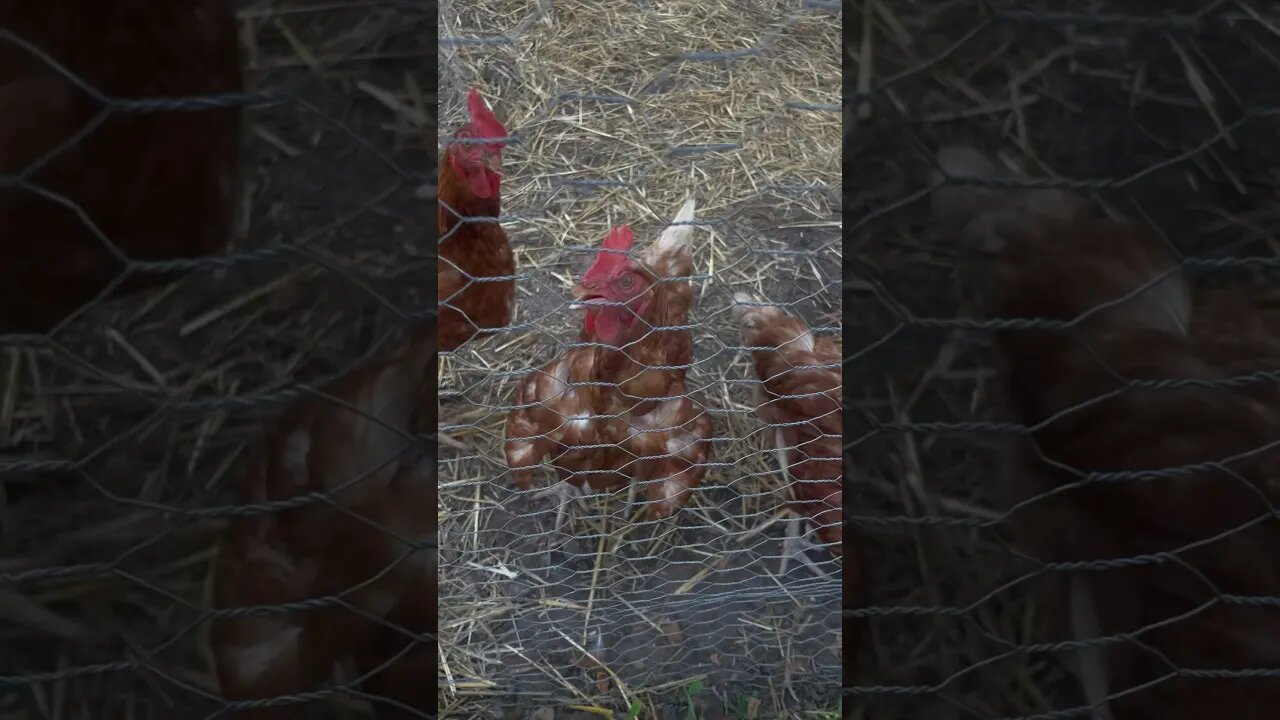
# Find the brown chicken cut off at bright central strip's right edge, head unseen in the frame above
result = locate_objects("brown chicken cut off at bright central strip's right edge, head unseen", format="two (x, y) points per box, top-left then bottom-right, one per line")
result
(733, 292), (844, 575)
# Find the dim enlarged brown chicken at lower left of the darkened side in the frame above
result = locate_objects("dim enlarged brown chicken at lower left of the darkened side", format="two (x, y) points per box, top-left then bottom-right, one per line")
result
(210, 322), (436, 720)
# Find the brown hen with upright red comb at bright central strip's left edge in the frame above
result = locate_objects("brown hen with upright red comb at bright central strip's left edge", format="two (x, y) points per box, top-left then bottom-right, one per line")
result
(435, 88), (516, 352)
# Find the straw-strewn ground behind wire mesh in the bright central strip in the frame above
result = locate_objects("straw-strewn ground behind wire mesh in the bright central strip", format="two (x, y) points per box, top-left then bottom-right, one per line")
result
(439, 0), (841, 717)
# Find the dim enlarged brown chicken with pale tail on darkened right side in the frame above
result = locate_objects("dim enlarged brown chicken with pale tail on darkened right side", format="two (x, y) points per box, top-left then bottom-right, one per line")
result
(934, 147), (1280, 720)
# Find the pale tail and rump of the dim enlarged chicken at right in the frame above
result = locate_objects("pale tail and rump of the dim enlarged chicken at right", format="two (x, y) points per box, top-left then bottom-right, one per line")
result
(932, 146), (1190, 333)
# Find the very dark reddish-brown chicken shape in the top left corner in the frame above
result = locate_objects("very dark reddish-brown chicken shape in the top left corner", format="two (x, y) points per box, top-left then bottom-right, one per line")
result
(0, 0), (242, 333)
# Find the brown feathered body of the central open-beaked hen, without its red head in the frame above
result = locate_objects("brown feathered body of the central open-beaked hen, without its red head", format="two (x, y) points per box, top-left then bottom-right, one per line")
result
(506, 206), (710, 518)
